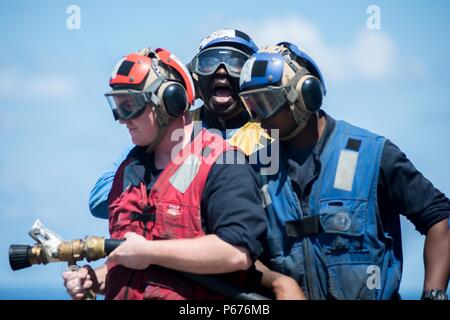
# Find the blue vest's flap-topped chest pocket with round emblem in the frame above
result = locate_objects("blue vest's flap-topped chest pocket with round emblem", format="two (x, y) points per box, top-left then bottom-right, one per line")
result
(318, 199), (367, 254)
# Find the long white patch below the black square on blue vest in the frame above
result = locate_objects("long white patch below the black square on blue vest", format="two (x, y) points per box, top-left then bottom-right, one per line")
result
(333, 149), (359, 191)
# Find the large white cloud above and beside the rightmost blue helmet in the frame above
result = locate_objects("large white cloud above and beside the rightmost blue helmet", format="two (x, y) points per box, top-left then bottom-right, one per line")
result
(239, 16), (426, 83)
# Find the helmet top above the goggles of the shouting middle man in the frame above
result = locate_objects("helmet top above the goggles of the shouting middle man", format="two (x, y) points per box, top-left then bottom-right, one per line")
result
(198, 28), (258, 55)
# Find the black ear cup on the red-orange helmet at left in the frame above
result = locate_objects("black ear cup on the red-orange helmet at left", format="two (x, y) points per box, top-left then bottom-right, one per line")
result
(158, 81), (189, 118)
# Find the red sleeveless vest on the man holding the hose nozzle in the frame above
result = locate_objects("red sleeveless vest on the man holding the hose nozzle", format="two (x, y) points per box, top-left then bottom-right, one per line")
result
(105, 129), (241, 300)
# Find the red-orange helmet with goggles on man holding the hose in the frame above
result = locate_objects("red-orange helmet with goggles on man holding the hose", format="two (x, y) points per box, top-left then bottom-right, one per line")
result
(105, 48), (195, 125)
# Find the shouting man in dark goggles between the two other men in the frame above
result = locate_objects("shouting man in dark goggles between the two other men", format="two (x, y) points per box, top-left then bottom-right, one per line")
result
(188, 29), (269, 151)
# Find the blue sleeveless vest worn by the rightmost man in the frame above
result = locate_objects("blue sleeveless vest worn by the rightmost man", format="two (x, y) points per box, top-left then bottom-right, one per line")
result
(261, 121), (401, 300)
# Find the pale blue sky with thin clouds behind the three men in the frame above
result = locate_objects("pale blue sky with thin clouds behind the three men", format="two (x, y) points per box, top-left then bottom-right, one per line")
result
(0, 0), (450, 299)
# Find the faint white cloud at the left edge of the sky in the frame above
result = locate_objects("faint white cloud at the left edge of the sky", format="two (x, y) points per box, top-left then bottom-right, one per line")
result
(0, 68), (75, 101)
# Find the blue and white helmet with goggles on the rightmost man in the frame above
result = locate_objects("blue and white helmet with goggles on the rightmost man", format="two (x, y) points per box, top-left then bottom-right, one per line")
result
(239, 43), (325, 122)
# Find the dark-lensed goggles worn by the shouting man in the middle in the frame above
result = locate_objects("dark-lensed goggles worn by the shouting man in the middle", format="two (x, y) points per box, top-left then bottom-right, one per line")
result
(191, 47), (250, 78)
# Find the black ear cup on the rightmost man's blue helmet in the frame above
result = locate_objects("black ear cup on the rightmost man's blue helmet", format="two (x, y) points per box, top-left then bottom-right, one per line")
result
(295, 75), (323, 112)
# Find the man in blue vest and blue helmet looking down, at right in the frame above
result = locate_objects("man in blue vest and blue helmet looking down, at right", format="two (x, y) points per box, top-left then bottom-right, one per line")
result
(240, 42), (450, 299)
